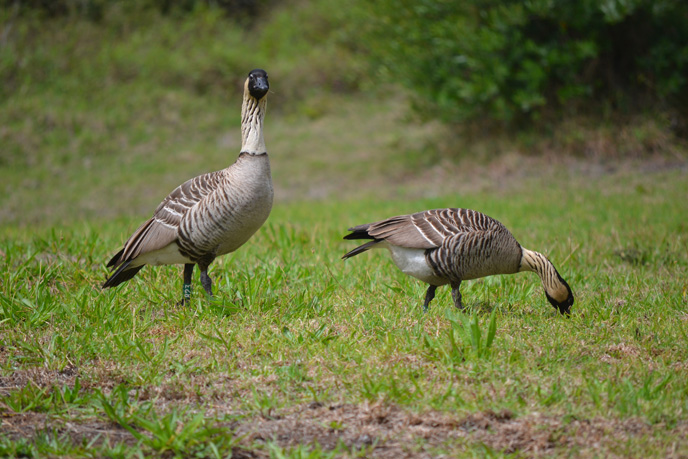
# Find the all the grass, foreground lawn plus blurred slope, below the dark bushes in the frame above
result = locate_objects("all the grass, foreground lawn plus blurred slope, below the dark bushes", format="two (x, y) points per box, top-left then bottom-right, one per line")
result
(0, 5), (688, 458)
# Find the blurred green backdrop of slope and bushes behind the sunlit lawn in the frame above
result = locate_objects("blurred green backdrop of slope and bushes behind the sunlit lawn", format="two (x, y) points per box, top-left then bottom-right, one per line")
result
(0, 0), (688, 222)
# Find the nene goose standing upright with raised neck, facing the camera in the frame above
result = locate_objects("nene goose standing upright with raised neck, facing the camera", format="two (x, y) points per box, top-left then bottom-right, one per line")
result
(103, 69), (273, 304)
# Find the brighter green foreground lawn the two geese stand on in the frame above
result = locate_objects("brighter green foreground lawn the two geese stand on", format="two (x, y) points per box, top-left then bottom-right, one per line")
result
(0, 172), (688, 457)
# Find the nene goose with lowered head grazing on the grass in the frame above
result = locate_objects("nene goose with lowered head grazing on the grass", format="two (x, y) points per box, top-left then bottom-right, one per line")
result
(342, 209), (573, 314)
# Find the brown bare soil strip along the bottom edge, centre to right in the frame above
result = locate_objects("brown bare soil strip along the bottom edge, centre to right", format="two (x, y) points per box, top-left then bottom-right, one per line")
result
(236, 403), (688, 458)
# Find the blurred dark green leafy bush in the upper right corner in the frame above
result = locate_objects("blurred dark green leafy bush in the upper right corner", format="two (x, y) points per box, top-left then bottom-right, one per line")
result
(355, 0), (688, 125)
